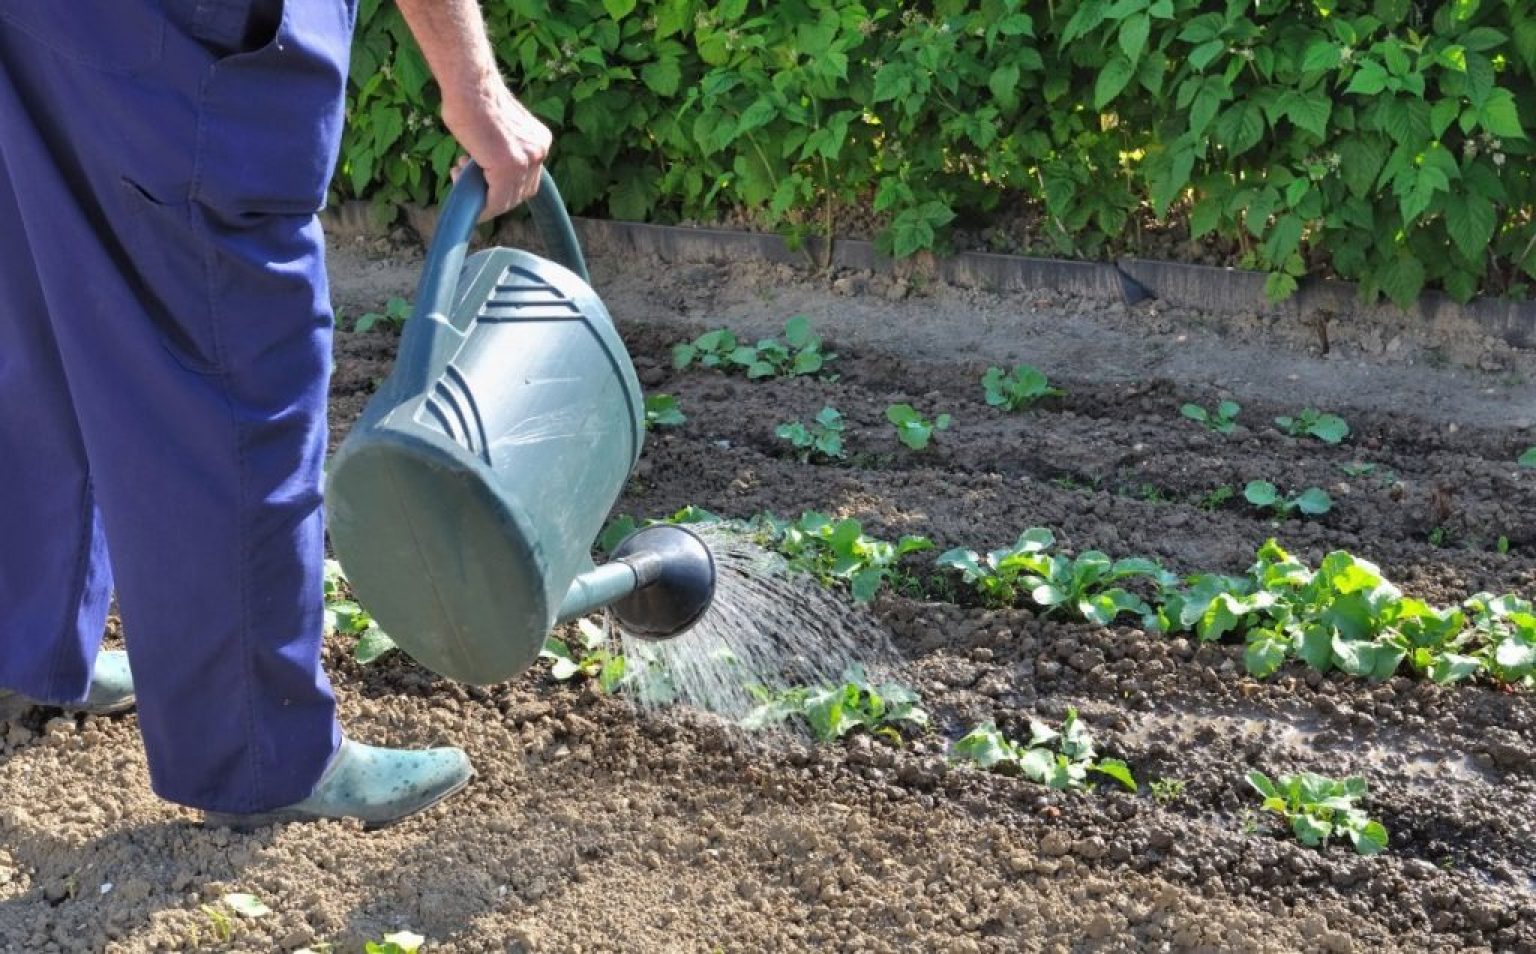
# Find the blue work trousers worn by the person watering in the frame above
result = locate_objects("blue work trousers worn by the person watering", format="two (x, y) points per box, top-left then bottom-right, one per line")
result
(0, 0), (355, 813)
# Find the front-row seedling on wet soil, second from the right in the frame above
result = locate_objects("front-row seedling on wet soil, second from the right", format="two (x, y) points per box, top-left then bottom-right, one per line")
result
(949, 708), (1137, 791)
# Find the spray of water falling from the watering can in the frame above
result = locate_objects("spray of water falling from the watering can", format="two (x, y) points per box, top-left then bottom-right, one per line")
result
(619, 527), (894, 722)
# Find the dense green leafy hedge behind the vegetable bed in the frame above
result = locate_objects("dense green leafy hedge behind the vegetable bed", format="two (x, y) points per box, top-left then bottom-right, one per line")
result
(335, 0), (1536, 304)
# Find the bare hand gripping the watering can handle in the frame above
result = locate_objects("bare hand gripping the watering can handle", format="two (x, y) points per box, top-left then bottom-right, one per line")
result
(442, 77), (553, 221)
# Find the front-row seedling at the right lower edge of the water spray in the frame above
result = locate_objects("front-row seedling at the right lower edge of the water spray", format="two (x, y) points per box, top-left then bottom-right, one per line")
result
(742, 665), (928, 742)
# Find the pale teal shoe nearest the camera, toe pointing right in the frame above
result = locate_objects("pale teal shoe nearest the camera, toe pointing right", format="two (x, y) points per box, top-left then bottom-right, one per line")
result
(203, 739), (475, 831)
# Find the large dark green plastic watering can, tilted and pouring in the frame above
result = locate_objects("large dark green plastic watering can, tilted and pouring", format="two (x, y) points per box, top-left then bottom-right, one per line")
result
(326, 164), (716, 685)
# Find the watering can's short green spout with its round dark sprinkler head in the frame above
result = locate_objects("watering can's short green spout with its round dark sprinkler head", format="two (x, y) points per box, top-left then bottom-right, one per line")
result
(556, 525), (716, 639)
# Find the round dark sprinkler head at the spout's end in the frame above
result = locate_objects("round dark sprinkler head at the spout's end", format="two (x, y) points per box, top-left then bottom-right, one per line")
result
(608, 524), (716, 641)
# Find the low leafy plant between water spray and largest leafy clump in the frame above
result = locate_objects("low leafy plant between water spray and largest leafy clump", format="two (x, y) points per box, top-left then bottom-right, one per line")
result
(938, 527), (1166, 625)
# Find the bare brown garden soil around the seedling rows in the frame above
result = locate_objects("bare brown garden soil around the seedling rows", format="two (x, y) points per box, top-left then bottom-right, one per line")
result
(0, 231), (1536, 952)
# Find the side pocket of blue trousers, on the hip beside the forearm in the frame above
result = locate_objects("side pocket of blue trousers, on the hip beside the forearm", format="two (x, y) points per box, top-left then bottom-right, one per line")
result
(192, 0), (352, 220)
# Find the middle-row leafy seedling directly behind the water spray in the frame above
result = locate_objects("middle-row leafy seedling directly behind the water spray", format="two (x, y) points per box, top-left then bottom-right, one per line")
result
(756, 512), (934, 602)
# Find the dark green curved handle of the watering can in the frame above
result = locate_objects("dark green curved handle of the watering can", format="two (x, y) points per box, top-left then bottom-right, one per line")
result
(396, 161), (591, 392)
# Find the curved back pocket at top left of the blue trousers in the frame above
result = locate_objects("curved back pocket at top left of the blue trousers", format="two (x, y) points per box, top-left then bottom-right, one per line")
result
(0, 0), (166, 77)
